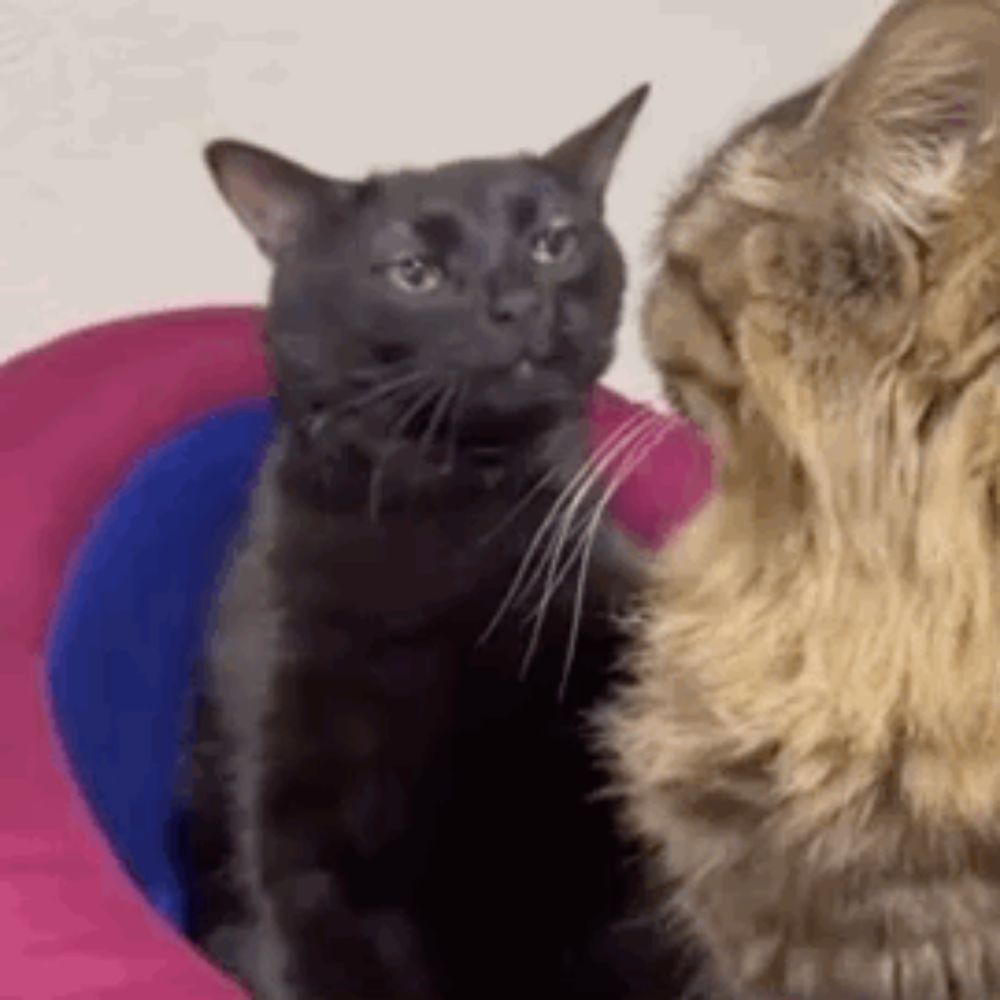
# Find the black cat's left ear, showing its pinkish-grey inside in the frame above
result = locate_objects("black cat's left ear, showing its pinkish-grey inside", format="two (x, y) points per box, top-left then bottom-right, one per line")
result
(205, 139), (352, 260)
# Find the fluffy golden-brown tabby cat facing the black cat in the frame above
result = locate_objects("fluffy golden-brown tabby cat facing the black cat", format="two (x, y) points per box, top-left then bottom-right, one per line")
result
(603, 0), (1000, 1000)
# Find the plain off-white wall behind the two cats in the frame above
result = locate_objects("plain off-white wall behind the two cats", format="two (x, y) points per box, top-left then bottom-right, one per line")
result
(0, 0), (886, 396)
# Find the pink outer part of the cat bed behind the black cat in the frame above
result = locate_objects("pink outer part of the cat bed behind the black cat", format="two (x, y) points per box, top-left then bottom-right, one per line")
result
(0, 308), (711, 1000)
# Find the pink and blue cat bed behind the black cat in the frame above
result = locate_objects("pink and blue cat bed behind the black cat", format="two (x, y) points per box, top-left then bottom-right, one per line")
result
(0, 309), (710, 1000)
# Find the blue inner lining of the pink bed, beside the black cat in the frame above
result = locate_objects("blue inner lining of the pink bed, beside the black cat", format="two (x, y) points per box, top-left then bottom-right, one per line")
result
(48, 400), (273, 927)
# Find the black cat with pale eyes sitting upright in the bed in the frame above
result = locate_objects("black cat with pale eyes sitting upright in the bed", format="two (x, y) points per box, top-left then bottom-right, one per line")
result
(193, 87), (680, 1000)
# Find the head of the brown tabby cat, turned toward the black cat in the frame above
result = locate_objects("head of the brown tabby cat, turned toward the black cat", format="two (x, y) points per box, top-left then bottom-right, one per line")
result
(644, 0), (1000, 512)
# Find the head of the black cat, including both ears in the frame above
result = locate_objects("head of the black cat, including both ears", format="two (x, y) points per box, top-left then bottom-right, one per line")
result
(206, 87), (648, 472)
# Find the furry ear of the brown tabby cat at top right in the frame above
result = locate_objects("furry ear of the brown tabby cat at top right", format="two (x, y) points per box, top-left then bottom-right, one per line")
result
(803, 0), (1000, 230)
